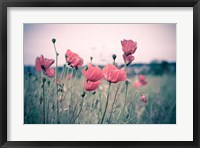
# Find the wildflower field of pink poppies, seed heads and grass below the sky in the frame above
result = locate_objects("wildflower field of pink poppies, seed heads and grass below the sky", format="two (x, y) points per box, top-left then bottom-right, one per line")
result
(24, 39), (176, 124)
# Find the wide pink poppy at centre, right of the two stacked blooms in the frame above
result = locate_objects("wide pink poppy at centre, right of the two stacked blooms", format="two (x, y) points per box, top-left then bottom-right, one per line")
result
(103, 64), (127, 83)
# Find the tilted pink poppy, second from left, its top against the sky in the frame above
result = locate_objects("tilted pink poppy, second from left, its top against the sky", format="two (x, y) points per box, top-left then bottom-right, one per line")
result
(65, 49), (83, 68)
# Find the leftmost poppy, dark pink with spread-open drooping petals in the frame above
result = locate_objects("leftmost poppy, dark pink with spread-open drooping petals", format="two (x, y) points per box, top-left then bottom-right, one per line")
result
(35, 55), (55, 77)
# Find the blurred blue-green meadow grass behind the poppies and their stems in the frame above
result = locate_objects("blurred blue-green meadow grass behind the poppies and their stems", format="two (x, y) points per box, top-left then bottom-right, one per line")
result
(24, 71), (176, 124)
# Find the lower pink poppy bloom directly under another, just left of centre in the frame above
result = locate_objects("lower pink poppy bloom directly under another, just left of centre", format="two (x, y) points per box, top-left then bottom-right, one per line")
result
(83, 80), (101, 91)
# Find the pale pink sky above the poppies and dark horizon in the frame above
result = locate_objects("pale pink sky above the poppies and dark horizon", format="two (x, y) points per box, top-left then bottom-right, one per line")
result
(24, 24), (176, 65)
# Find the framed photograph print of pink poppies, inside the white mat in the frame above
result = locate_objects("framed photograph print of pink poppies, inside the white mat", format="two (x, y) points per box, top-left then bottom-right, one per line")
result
(23, 23), (176, 124)
